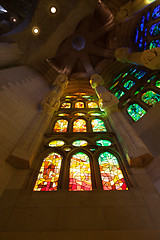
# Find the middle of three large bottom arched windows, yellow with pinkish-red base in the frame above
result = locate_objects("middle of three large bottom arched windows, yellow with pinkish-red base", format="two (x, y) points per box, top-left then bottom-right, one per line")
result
(69, 152), (92, 191)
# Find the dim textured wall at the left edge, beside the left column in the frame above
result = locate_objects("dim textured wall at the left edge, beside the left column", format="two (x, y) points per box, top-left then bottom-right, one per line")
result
(0, 66), (49, 194)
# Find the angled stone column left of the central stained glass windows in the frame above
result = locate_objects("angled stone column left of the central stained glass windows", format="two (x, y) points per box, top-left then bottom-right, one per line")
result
(7, 74), (68, 168)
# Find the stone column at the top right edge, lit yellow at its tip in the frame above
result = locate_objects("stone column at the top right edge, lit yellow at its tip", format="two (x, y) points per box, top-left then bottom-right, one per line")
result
(116, 0), (156, 22)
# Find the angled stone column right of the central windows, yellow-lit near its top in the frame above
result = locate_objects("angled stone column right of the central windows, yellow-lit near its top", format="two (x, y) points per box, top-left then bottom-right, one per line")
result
(90, 74), (153, 167)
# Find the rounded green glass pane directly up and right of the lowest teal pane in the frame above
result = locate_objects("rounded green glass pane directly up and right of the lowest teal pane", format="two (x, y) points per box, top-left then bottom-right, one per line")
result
(142, 91), (160, 106)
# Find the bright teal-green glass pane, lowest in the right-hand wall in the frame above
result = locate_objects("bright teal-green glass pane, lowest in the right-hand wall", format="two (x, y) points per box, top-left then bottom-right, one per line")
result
(127, 103), (146, 121)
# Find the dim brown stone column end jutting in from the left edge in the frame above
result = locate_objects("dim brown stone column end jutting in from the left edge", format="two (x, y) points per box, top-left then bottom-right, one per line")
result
(0, 43), (22, 67)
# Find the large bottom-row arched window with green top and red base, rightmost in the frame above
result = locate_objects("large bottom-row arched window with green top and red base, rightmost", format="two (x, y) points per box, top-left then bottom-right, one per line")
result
(98, 152), (128, 190)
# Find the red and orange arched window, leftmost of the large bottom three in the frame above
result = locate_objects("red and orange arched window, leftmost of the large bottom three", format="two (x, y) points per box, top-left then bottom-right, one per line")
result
(33, 153), (62, 191)
